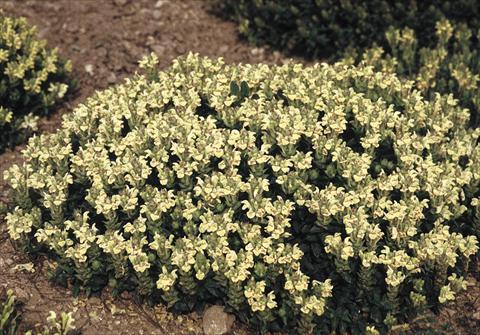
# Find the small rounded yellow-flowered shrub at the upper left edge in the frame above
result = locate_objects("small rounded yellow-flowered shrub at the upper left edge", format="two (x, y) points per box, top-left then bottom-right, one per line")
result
(0, 11), (71, 152)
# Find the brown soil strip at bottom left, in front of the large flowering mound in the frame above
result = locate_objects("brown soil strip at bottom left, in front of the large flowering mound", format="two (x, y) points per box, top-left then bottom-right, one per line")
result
(0, 227), (203, 335)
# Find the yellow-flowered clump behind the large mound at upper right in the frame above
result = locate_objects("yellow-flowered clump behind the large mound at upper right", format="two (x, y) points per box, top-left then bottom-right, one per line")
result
(344, 20), (480, 127)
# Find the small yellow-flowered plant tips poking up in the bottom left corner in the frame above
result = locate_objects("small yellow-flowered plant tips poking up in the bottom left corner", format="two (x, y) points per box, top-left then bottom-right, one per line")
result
(0, 290), (75, 335)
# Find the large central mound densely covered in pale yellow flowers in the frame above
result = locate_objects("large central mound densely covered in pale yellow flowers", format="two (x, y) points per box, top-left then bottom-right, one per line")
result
(5, 54), (480, 334)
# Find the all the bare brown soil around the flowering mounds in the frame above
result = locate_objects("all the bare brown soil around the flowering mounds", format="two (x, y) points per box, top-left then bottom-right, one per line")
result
(0, 0), (480, 334)
